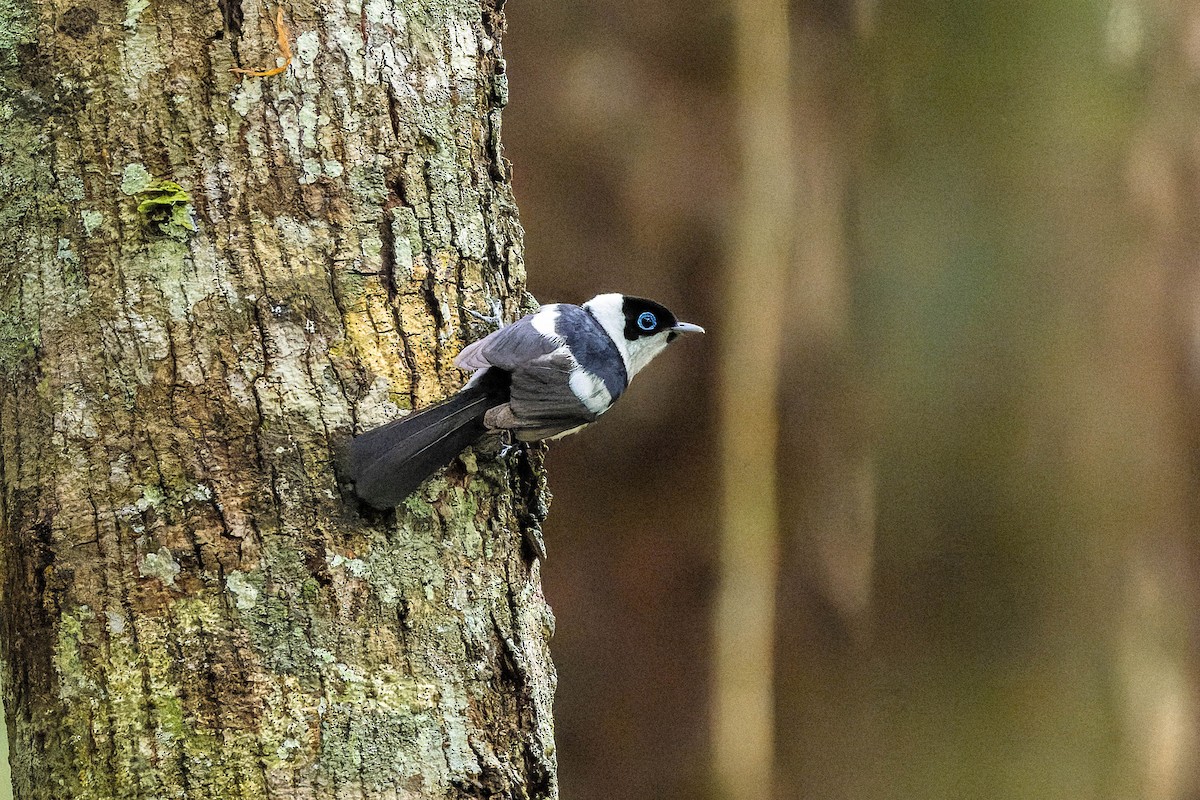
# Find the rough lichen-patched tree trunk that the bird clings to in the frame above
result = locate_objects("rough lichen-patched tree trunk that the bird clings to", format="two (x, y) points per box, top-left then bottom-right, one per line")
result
(0, 0), (557, 800)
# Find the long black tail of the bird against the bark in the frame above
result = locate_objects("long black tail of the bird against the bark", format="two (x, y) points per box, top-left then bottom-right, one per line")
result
(350, 368), (509, 509)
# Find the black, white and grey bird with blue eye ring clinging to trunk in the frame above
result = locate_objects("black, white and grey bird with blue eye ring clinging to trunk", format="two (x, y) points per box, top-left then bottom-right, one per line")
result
(350, 294), (704, 509)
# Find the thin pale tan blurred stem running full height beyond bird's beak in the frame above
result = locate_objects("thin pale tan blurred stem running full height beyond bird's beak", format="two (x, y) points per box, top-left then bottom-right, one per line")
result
(712, 0), (796, 800)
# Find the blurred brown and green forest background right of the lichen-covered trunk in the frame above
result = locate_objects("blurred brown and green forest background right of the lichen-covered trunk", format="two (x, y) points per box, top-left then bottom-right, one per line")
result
(504, 0), (1200, 800)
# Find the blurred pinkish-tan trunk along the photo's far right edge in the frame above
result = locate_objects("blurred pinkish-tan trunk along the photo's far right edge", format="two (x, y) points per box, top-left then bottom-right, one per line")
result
(1123, 0), (1200, 799)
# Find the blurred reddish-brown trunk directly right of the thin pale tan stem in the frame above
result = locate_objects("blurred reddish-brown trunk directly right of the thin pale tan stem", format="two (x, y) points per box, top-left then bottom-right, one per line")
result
(776, 2), (880, 800)
